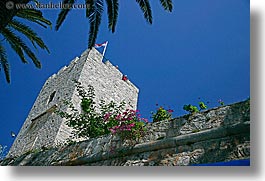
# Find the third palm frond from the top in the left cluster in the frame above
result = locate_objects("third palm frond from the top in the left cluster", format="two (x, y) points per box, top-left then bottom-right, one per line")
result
(1, 27), (41, 68)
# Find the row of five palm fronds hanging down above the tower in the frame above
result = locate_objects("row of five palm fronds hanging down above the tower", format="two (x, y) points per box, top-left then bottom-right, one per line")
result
(55, 0), (173, 48)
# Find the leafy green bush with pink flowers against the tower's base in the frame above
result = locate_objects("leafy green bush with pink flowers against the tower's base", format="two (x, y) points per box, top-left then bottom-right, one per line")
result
(56, 81), (148, 143)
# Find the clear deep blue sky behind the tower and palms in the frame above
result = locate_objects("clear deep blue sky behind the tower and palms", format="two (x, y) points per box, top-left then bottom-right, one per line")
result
(0, 0), (250, 152)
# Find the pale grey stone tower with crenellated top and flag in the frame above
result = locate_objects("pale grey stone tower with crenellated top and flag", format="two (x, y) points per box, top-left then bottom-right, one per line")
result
(7, 48), (139, 157)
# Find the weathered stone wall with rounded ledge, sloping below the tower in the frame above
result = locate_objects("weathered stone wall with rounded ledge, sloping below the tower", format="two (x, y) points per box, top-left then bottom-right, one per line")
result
(1, 100), (250, 166)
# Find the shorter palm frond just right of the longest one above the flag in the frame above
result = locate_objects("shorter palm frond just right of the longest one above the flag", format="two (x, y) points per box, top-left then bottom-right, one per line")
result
(106, 0), (119, 33)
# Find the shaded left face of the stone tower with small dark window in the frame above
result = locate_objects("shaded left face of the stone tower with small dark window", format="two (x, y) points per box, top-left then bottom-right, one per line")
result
(8, 55), (85, 157)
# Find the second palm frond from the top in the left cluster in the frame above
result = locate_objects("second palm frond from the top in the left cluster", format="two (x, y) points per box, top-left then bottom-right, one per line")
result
(8, 19), (50, 52)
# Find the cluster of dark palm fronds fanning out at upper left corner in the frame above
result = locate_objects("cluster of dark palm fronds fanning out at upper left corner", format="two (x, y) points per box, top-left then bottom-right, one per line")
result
(0, 4), (51, 83)
